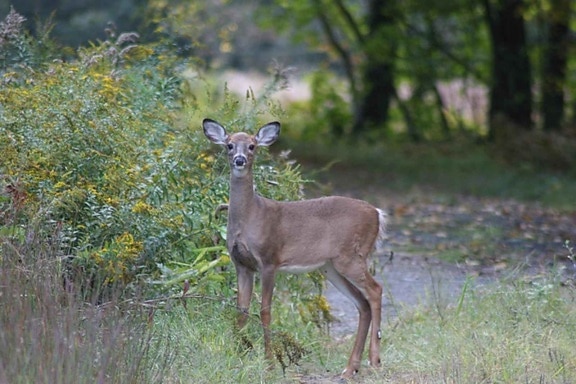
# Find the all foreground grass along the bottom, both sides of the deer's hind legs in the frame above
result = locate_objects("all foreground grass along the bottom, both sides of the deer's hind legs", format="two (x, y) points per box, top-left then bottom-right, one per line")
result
(0, 230), (576, 383)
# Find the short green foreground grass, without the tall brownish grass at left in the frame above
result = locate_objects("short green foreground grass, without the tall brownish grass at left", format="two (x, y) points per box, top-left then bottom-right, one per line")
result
(154, 276), (576, 383)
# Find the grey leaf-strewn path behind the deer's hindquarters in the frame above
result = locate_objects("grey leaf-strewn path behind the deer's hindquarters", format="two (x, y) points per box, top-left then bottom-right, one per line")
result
(304, 164), (576, 338)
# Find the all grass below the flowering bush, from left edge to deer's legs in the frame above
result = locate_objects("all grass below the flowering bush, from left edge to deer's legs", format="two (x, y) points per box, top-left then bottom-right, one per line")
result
(0, 225), (324, 384)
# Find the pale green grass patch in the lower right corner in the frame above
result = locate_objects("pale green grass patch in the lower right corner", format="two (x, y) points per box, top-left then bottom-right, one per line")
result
(383, 279), (576, 383)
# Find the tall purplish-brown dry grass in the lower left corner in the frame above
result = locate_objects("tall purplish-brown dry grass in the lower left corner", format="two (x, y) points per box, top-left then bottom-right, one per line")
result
(0, 233), (169, 383)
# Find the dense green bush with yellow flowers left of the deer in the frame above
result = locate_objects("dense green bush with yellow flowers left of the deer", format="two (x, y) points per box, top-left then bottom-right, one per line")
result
(0, 8), (301, 295)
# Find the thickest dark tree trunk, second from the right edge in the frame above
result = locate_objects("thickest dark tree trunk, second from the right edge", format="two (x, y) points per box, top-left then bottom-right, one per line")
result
(483, 0), (532, 140)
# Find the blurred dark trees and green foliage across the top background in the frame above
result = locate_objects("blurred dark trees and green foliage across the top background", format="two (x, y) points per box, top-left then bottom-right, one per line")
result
(6, 0), (576, 148)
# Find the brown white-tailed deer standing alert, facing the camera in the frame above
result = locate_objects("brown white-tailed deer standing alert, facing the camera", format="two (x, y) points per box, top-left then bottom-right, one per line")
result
(202, 119), (386, 377)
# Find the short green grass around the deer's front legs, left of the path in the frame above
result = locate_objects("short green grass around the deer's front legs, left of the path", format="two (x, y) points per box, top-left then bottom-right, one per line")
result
(143, 286), (347, 383)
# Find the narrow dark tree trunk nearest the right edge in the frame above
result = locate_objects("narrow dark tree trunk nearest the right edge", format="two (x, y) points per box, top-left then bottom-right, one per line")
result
(542, 0), (571, 131)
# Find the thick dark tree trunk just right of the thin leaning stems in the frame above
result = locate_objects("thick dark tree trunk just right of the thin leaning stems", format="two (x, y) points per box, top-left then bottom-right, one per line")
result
(352, 0), (396, 136)
